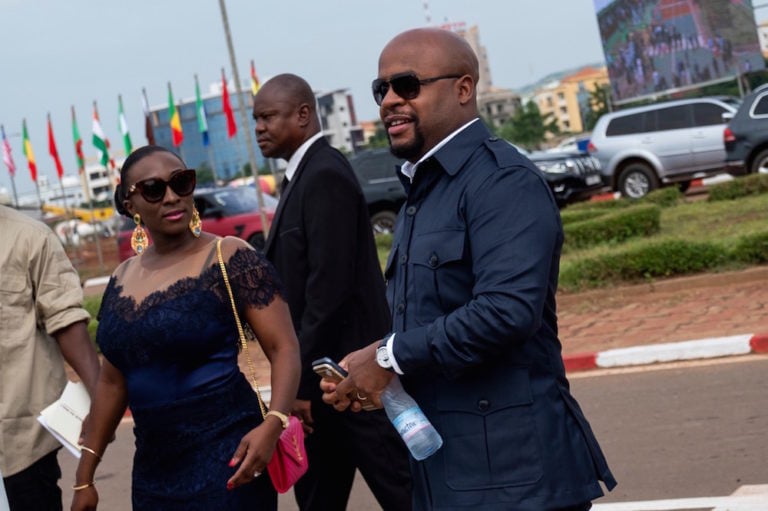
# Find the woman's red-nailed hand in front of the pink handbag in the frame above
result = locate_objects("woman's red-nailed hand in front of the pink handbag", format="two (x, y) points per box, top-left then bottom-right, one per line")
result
(227, 420), (282, 490)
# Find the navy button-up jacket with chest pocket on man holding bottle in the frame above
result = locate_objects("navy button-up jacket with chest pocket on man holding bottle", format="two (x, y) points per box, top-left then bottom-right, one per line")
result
(385, 121), (615, 511)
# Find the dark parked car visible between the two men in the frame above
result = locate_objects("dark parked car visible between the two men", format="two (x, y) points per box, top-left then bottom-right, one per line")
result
(349, 148), (405, 234)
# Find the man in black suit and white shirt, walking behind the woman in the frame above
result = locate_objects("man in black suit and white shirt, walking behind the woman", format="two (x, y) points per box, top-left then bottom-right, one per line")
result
(253, 74), (411, 511)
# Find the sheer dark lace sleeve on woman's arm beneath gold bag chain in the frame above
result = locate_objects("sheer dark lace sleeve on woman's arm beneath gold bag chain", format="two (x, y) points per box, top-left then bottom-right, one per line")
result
(226, 247), (284, 314)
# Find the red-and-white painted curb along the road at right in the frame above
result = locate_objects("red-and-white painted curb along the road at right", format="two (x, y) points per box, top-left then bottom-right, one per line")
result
(563, 333), (768, 373)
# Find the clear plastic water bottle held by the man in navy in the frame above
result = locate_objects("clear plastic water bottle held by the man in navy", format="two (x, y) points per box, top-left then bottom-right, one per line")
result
(381, 376), (443, 461)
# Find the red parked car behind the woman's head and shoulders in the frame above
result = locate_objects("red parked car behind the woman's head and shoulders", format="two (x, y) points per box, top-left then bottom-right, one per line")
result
(117, 186), (277, 261)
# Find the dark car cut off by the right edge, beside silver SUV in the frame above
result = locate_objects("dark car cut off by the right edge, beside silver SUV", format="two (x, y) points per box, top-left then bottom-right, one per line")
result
(723, 85), (768, 176)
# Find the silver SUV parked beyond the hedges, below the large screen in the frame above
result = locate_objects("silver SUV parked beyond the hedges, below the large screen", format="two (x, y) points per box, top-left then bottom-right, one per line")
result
(587, 96), (740, 199)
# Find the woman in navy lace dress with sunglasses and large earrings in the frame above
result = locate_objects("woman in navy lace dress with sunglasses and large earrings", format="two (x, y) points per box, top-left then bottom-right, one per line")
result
(72, 146), (300, 511)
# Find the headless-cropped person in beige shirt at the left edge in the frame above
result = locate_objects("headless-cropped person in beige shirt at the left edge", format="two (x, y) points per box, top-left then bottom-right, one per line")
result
(0, 206), (99, 511)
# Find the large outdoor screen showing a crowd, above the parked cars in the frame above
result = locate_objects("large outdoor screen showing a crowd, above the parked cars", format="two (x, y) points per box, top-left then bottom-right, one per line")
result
(594, 0), (765, 104)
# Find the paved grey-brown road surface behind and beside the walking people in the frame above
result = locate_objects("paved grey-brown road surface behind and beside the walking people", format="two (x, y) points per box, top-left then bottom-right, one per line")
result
(59, 355), (768, 511)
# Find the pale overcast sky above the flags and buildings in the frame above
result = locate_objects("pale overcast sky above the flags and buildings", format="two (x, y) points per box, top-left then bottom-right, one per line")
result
(0, 0), (768, 197)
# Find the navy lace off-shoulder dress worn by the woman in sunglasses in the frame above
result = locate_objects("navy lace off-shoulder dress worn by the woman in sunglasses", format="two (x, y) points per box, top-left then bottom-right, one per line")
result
(97, 248), (280, 511)
